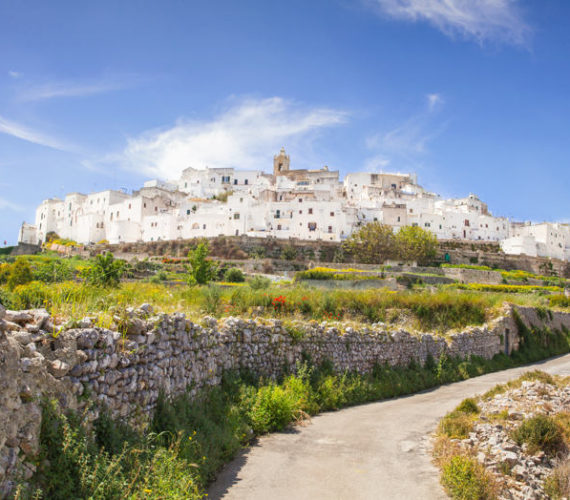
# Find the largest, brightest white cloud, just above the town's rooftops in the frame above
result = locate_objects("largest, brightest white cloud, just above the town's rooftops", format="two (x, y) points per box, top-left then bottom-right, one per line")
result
(118, 97), (347, 179)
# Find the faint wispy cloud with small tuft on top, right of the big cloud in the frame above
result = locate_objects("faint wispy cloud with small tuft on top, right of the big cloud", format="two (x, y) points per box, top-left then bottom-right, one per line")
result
(364, 93), (446, 170)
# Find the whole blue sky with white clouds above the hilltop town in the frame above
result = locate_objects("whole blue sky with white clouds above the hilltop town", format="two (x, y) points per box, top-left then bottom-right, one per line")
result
(0, 0), (570, 245)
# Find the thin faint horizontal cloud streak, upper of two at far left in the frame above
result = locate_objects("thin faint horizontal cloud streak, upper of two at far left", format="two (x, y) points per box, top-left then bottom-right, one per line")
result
(18, 76), (140, 101)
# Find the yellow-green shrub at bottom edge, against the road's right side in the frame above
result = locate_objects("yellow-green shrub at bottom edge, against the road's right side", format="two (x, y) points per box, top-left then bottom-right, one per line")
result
(441, 455), (495, 500)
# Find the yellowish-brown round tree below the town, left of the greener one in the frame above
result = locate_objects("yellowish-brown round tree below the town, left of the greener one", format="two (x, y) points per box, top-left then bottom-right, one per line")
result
(343, 222), (396, 264)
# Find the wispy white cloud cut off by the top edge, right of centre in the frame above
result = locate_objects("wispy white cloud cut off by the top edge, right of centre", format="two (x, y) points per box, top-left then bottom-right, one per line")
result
(367, 0), (531, 45)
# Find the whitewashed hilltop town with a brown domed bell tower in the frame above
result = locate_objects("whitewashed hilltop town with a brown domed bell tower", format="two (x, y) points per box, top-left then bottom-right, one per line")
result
(19, 148), (570, 260)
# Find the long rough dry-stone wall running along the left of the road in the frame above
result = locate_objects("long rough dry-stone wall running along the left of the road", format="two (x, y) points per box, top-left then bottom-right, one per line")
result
(0, 306), (570, 496)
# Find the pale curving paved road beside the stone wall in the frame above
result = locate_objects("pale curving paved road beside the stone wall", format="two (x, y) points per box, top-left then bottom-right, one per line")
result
(208, 355), (570, 500)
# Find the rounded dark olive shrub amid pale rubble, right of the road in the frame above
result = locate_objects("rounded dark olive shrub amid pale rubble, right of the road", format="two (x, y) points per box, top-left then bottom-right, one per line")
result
(511, 415), (564, 454)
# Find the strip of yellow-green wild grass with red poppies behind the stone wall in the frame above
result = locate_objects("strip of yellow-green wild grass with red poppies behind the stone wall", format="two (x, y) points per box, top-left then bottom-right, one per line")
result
(0, 281), (547, 332)
